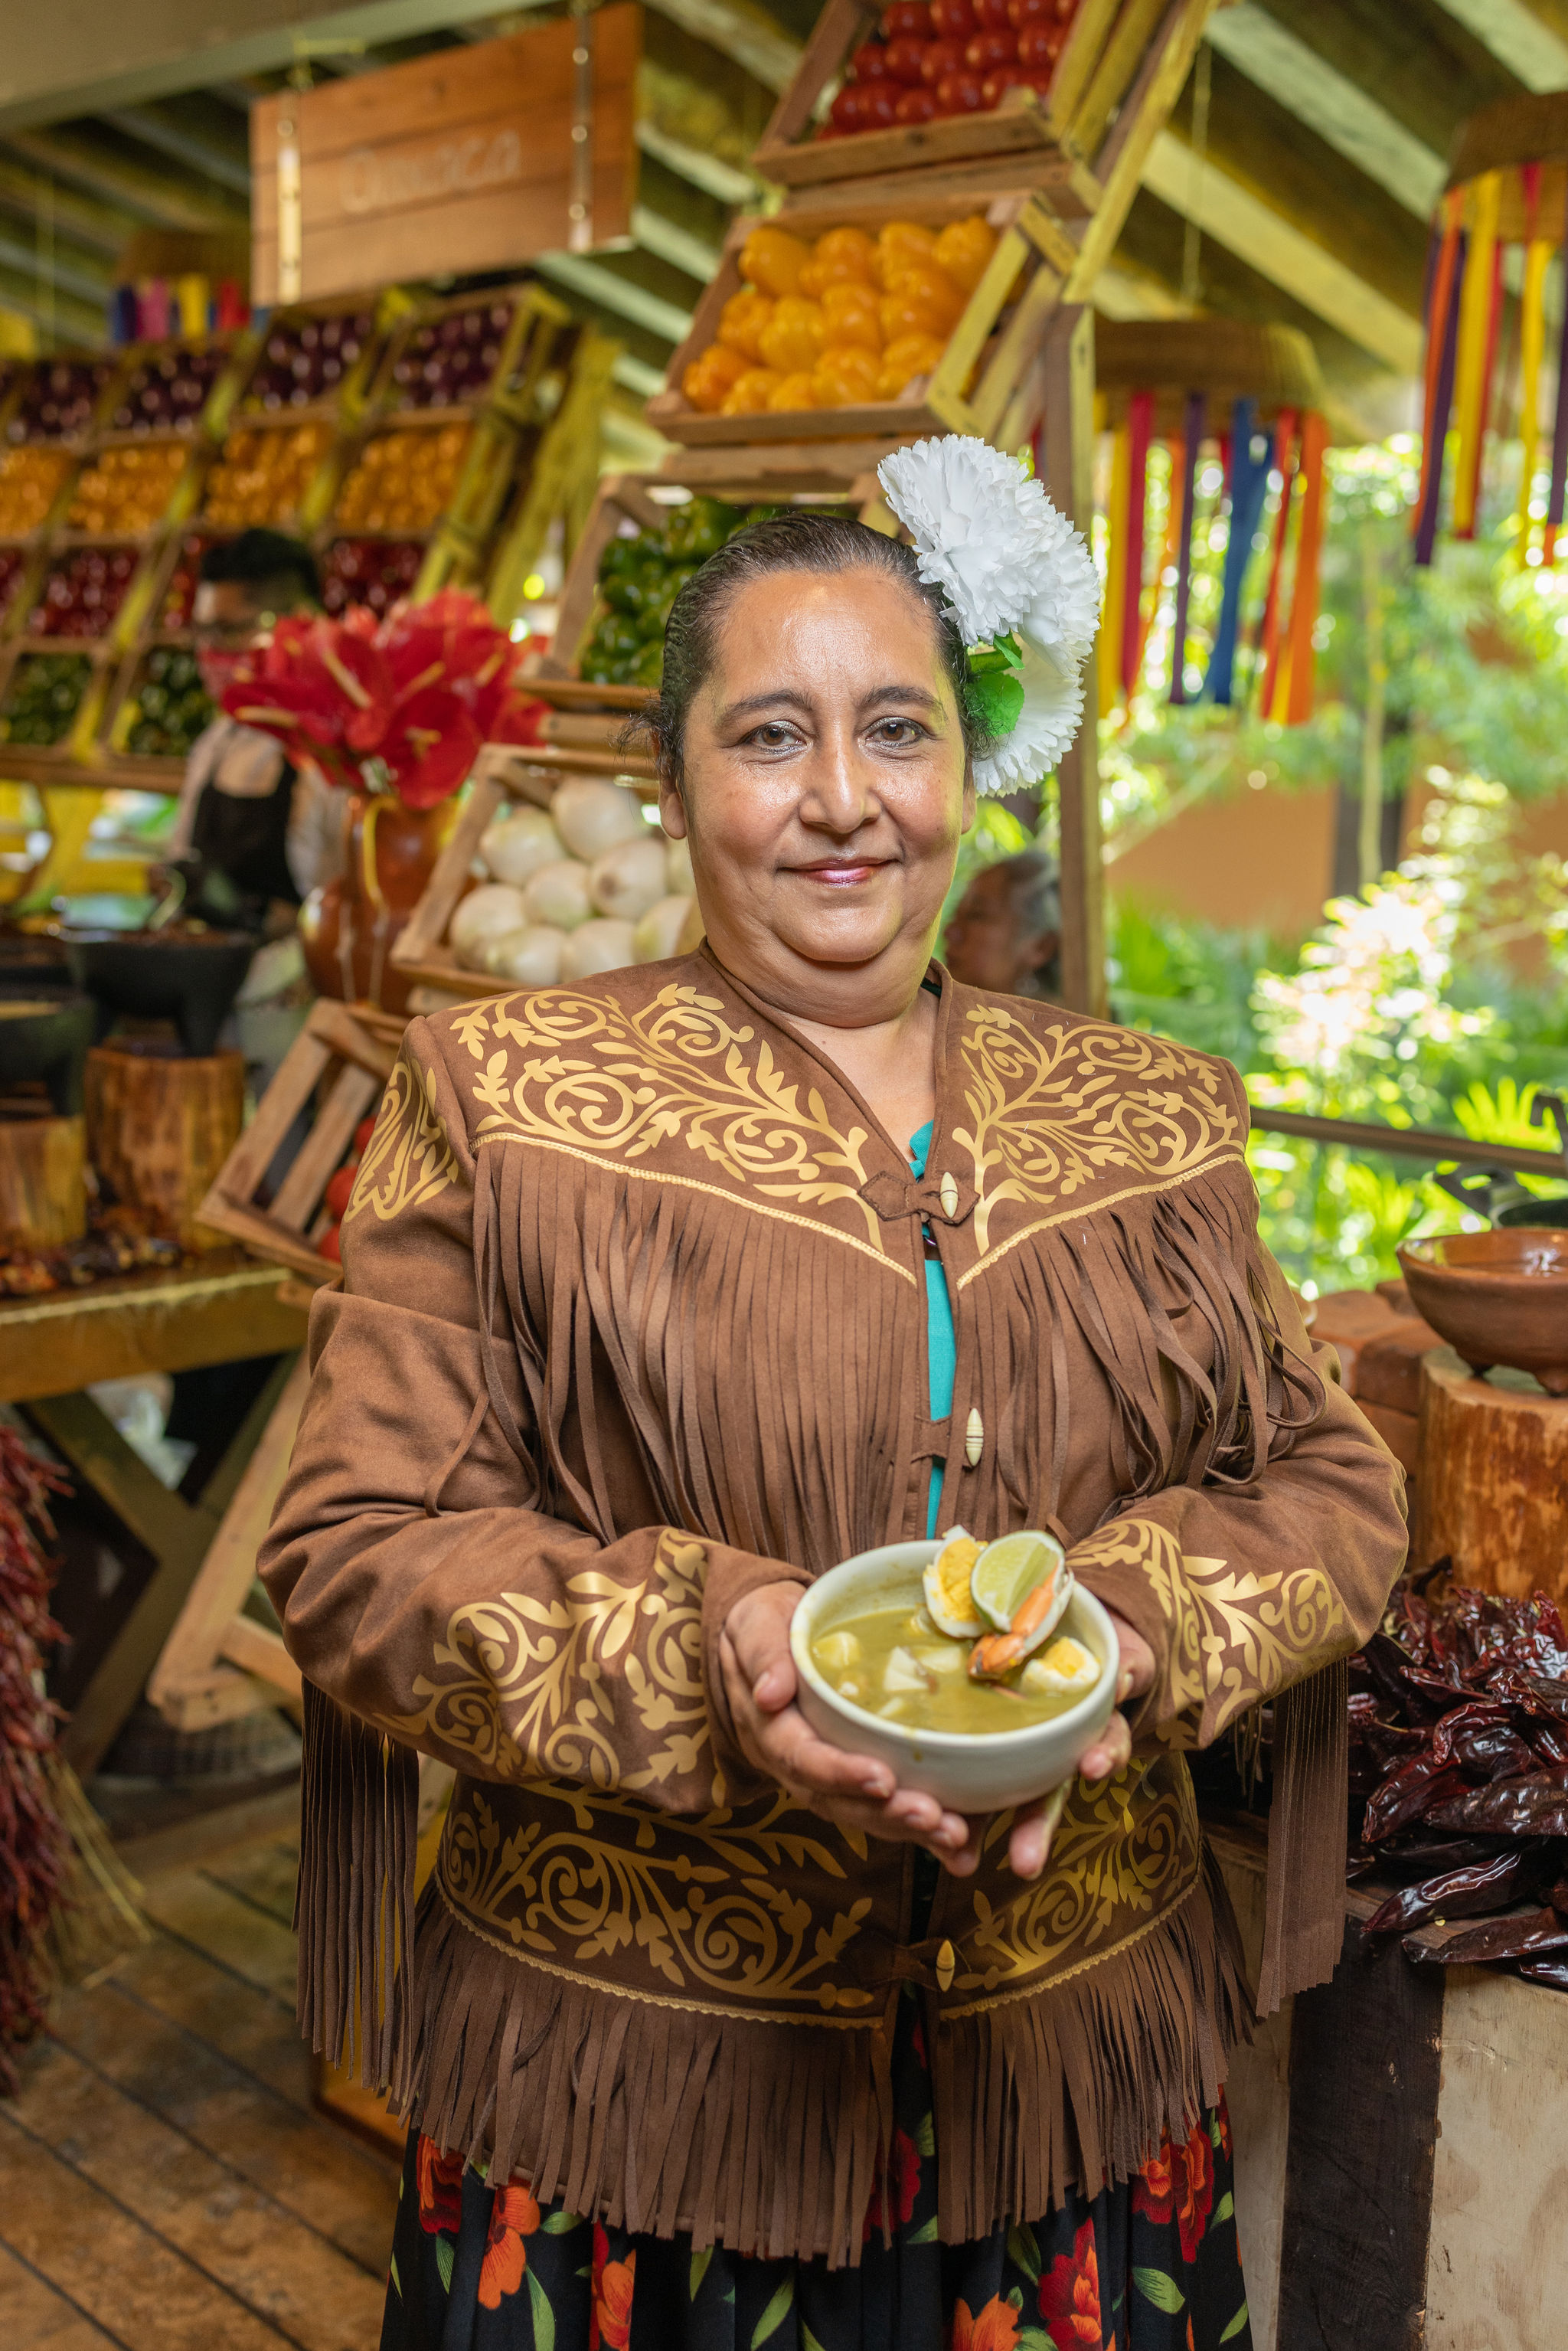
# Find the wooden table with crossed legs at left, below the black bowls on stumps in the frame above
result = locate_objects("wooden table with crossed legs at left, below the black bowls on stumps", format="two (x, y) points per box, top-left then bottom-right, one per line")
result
(0, 1248), (305, 1777)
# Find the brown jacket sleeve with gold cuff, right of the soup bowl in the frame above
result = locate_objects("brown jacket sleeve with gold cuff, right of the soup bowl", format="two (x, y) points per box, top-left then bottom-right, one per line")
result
(1067, 1114), (1406, 1747)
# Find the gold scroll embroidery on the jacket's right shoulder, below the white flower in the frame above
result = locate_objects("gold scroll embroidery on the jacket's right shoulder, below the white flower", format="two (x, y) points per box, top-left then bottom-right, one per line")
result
(952, 1004), (1243, 1255)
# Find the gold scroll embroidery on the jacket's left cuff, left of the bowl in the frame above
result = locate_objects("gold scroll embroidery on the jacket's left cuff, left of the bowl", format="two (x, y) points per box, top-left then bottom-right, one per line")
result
(390, 1529), (722, 1803)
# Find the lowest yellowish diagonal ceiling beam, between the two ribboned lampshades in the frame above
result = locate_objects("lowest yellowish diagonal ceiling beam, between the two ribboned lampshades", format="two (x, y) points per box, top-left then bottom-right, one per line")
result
(1142, 132), (1423, 376)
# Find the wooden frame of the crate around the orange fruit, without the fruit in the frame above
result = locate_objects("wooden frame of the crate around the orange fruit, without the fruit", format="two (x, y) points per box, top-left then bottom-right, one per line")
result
(646, 185), (1079, 451)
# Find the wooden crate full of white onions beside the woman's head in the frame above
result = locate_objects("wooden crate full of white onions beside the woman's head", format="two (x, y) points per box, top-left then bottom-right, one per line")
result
(393, 745), (698, 997)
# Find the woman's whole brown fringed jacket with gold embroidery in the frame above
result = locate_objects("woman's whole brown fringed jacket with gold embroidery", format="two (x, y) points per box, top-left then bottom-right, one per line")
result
(263, 950), (1403, 2261)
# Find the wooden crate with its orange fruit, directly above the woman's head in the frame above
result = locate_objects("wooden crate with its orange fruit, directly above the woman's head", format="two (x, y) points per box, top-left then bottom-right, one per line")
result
(646, 191), (1076, 446)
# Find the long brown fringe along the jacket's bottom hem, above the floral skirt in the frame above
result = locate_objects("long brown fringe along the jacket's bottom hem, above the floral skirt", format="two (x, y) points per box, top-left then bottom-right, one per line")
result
(383, 1857), (1248, 2269)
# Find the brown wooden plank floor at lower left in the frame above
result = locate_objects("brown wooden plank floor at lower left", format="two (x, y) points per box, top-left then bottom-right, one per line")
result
(0, 1805), (397, 2351)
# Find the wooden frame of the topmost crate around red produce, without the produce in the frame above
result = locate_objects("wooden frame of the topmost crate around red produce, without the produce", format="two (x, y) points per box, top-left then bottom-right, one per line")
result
(753, 0), (1114, 199)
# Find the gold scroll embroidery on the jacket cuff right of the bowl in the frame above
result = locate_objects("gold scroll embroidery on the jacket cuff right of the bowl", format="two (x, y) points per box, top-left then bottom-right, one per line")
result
(1072, 1516), (1354, 1747)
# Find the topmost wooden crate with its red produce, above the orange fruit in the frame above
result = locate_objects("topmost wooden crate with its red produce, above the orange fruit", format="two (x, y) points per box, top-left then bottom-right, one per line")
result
(753, 0), (1206, 196)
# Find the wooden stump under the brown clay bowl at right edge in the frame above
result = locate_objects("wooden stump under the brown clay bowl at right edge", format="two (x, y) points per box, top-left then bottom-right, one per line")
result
(1410, 1347), (1568, 1599)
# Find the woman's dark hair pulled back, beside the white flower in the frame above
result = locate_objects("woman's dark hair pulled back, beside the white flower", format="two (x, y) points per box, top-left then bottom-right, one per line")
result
(628, 512), (990, 787)
